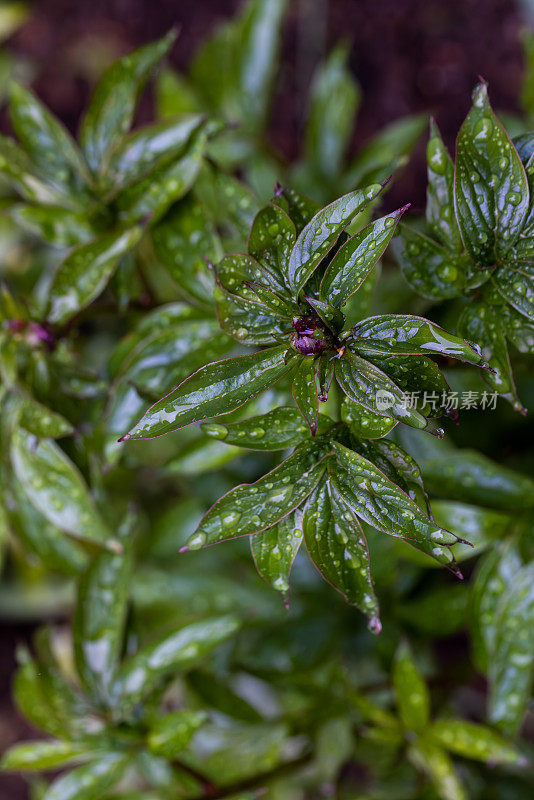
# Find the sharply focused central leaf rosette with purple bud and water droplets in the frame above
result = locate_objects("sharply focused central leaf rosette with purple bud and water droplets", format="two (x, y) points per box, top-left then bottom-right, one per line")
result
(121, 184), (498, 630)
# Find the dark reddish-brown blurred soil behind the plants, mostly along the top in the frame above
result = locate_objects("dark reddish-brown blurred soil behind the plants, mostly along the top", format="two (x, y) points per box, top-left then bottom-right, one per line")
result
(0, 0), (524, 800)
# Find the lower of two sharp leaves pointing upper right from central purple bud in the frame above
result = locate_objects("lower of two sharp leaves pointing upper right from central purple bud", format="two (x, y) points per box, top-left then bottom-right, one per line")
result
(320, 206), (408, 308)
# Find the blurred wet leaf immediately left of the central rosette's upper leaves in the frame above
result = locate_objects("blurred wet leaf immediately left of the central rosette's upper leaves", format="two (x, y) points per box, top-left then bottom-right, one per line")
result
(152, 193), (222, 308)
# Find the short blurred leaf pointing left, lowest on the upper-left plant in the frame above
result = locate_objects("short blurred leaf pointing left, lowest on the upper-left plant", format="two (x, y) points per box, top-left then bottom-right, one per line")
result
(10, 204), (95, 247)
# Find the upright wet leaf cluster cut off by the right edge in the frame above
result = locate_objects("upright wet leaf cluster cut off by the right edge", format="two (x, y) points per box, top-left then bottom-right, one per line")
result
(394, 83), (534, 412)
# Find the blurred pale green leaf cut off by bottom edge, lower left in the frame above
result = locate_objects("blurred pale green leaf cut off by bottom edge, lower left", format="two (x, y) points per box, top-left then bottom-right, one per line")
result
(43, 753), (130, 800)
